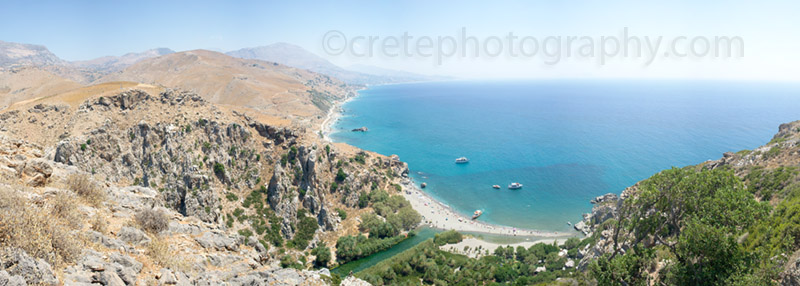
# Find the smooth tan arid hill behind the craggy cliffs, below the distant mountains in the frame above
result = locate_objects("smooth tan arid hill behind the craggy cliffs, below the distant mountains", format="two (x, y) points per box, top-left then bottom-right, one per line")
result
(98, 50), (351, 124)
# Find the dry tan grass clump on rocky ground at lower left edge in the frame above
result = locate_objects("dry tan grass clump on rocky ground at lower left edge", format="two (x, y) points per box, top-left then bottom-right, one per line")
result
(0, 189), (83, 266)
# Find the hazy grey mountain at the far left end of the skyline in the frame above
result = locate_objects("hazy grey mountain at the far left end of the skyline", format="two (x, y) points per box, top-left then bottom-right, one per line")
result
(0, 41), (67, 68)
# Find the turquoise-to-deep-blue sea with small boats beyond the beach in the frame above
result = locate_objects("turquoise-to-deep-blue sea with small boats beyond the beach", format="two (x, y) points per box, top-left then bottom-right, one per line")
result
(331, 80), (800, 231)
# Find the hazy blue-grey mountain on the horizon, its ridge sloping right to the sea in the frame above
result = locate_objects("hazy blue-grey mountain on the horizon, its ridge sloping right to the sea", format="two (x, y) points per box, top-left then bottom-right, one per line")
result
(227, 43), (438, 84)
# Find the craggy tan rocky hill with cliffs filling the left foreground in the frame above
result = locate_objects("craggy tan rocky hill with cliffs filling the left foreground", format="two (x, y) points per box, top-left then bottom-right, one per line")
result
(0, 86), (408, 285)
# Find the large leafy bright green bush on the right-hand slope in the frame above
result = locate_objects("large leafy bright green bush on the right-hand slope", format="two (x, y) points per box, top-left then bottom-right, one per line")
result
(591, 168), (769, 285)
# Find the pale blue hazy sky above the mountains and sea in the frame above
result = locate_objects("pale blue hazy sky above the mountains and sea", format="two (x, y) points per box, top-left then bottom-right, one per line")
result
(0, 0), (800, 81)
